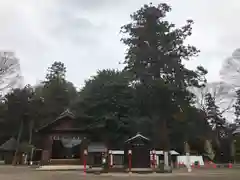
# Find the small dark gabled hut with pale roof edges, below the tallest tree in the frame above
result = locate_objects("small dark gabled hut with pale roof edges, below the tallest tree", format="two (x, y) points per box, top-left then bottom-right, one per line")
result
(125, 133), (151, 168)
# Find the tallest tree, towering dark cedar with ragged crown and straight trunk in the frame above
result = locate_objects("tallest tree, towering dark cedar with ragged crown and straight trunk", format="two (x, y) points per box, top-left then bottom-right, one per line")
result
(121, 3), (207, 148)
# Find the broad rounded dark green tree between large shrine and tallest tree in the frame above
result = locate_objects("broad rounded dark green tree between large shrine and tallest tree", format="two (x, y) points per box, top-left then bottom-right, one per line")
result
(74, 69), (133, 145)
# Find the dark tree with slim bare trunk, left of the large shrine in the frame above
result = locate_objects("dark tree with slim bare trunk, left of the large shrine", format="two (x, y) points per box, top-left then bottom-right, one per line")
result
(2, 85), (38, 163)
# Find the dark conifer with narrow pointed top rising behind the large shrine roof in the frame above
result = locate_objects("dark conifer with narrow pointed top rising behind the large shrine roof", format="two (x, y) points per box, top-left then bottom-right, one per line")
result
(38, 62), (77, 124)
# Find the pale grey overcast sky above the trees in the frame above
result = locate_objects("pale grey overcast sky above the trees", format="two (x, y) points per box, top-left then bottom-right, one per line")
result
(0, 0), (240, 86)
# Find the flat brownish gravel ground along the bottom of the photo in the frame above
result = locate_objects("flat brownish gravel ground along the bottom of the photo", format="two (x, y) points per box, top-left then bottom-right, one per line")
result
(0, 166), (240, 180)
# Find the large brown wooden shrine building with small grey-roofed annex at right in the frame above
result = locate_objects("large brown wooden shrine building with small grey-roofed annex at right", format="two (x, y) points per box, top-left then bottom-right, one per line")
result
(37, 110), (107, 164)
